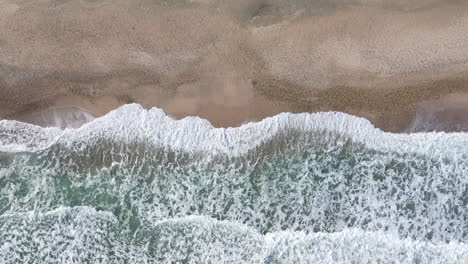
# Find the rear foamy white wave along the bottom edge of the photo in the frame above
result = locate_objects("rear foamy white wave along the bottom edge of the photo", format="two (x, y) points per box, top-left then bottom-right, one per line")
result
(0, 207), (468, 264)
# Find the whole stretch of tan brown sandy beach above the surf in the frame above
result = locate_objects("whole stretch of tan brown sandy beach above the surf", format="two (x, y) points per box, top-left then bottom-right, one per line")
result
(0, 0), (468, 131)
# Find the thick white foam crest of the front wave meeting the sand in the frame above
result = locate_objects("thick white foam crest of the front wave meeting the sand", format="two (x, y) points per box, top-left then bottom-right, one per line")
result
(0, 104), (468, 159)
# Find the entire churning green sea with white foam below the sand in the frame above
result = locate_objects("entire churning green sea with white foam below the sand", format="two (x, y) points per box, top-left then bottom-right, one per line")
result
(0, 105), (468, 263)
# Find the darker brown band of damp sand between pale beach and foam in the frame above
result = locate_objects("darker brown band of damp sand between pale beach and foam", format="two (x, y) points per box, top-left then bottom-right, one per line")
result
(0, 67), (468, 133)
